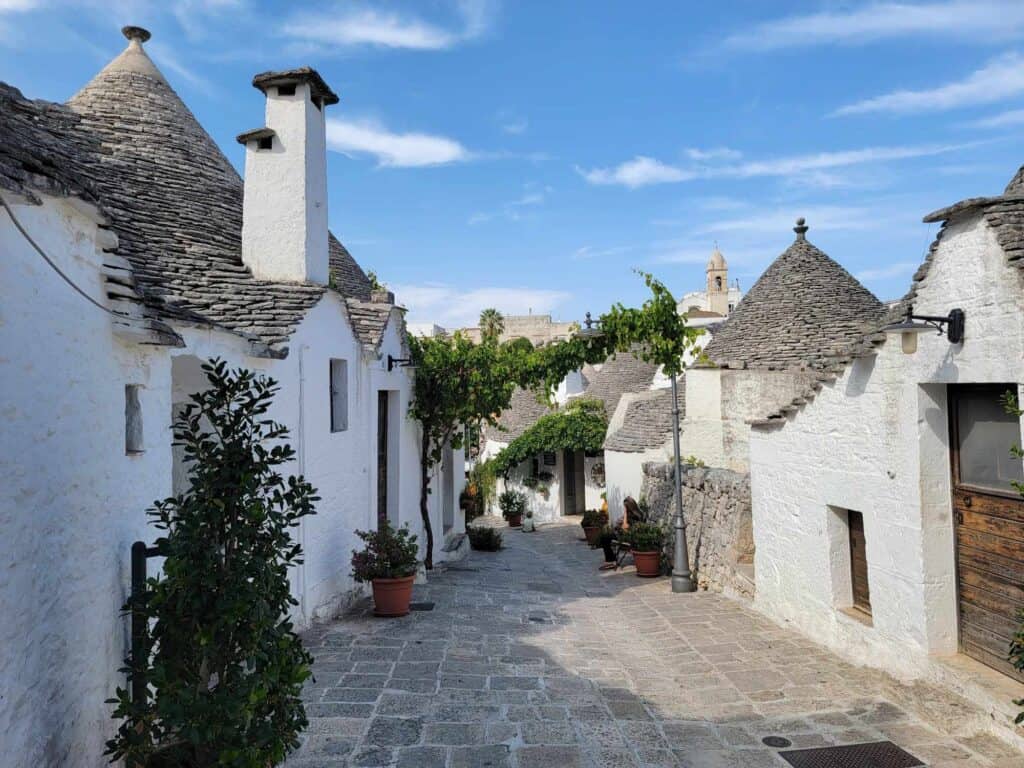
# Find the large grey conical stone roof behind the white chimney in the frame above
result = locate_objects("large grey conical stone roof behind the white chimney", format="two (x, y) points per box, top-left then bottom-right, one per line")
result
(60, 28), (372, 345)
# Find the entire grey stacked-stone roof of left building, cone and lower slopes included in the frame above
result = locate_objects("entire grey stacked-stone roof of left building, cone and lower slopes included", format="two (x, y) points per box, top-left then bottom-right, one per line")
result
(0, 30), (393, 356)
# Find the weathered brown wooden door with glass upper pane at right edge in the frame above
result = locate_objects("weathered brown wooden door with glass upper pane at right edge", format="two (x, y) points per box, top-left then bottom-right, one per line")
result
(950, 384), (1024, 681)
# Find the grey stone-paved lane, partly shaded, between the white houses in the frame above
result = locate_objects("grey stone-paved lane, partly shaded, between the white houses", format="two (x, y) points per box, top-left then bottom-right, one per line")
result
(287, 518), (1024, 768)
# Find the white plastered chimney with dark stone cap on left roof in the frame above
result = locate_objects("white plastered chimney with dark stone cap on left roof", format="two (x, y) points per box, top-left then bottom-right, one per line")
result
(239, 67), (338, 285)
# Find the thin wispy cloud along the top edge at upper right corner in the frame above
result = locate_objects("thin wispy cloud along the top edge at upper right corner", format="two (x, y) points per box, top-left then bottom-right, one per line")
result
(724, 0), (1024, 51)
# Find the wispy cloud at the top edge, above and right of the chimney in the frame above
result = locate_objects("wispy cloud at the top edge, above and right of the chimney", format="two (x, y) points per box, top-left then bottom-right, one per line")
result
(284, 0), (494, 50)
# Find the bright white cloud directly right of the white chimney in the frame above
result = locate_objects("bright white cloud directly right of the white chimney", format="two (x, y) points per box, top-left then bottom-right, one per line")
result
(327, 118), (472, 168)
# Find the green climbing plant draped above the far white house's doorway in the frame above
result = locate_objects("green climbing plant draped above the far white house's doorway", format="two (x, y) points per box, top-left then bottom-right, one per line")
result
(494, 399), (608, 476)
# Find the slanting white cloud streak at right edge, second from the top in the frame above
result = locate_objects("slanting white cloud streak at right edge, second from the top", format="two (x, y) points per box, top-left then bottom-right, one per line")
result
(833, 52), (1024, 116)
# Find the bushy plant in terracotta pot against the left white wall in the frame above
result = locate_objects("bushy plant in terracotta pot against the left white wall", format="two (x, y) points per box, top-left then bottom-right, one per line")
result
(352, 520), (420, 616)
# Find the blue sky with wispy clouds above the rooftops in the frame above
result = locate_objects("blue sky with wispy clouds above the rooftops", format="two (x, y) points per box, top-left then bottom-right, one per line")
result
(0, 0), (1024, 326)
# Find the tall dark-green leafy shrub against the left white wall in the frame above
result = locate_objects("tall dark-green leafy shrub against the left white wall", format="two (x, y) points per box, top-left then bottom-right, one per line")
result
(106, 360), (318, 768)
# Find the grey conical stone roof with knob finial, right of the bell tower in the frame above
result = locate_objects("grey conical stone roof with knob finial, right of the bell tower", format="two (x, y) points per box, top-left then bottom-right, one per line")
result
(705, 219), (886, 370)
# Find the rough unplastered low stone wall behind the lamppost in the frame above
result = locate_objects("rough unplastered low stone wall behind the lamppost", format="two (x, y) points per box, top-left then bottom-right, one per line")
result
(641, 462), (754, 598)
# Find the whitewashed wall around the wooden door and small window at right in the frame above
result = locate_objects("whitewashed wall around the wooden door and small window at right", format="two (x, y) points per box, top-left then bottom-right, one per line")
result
(751, 215), (1024, 675)
